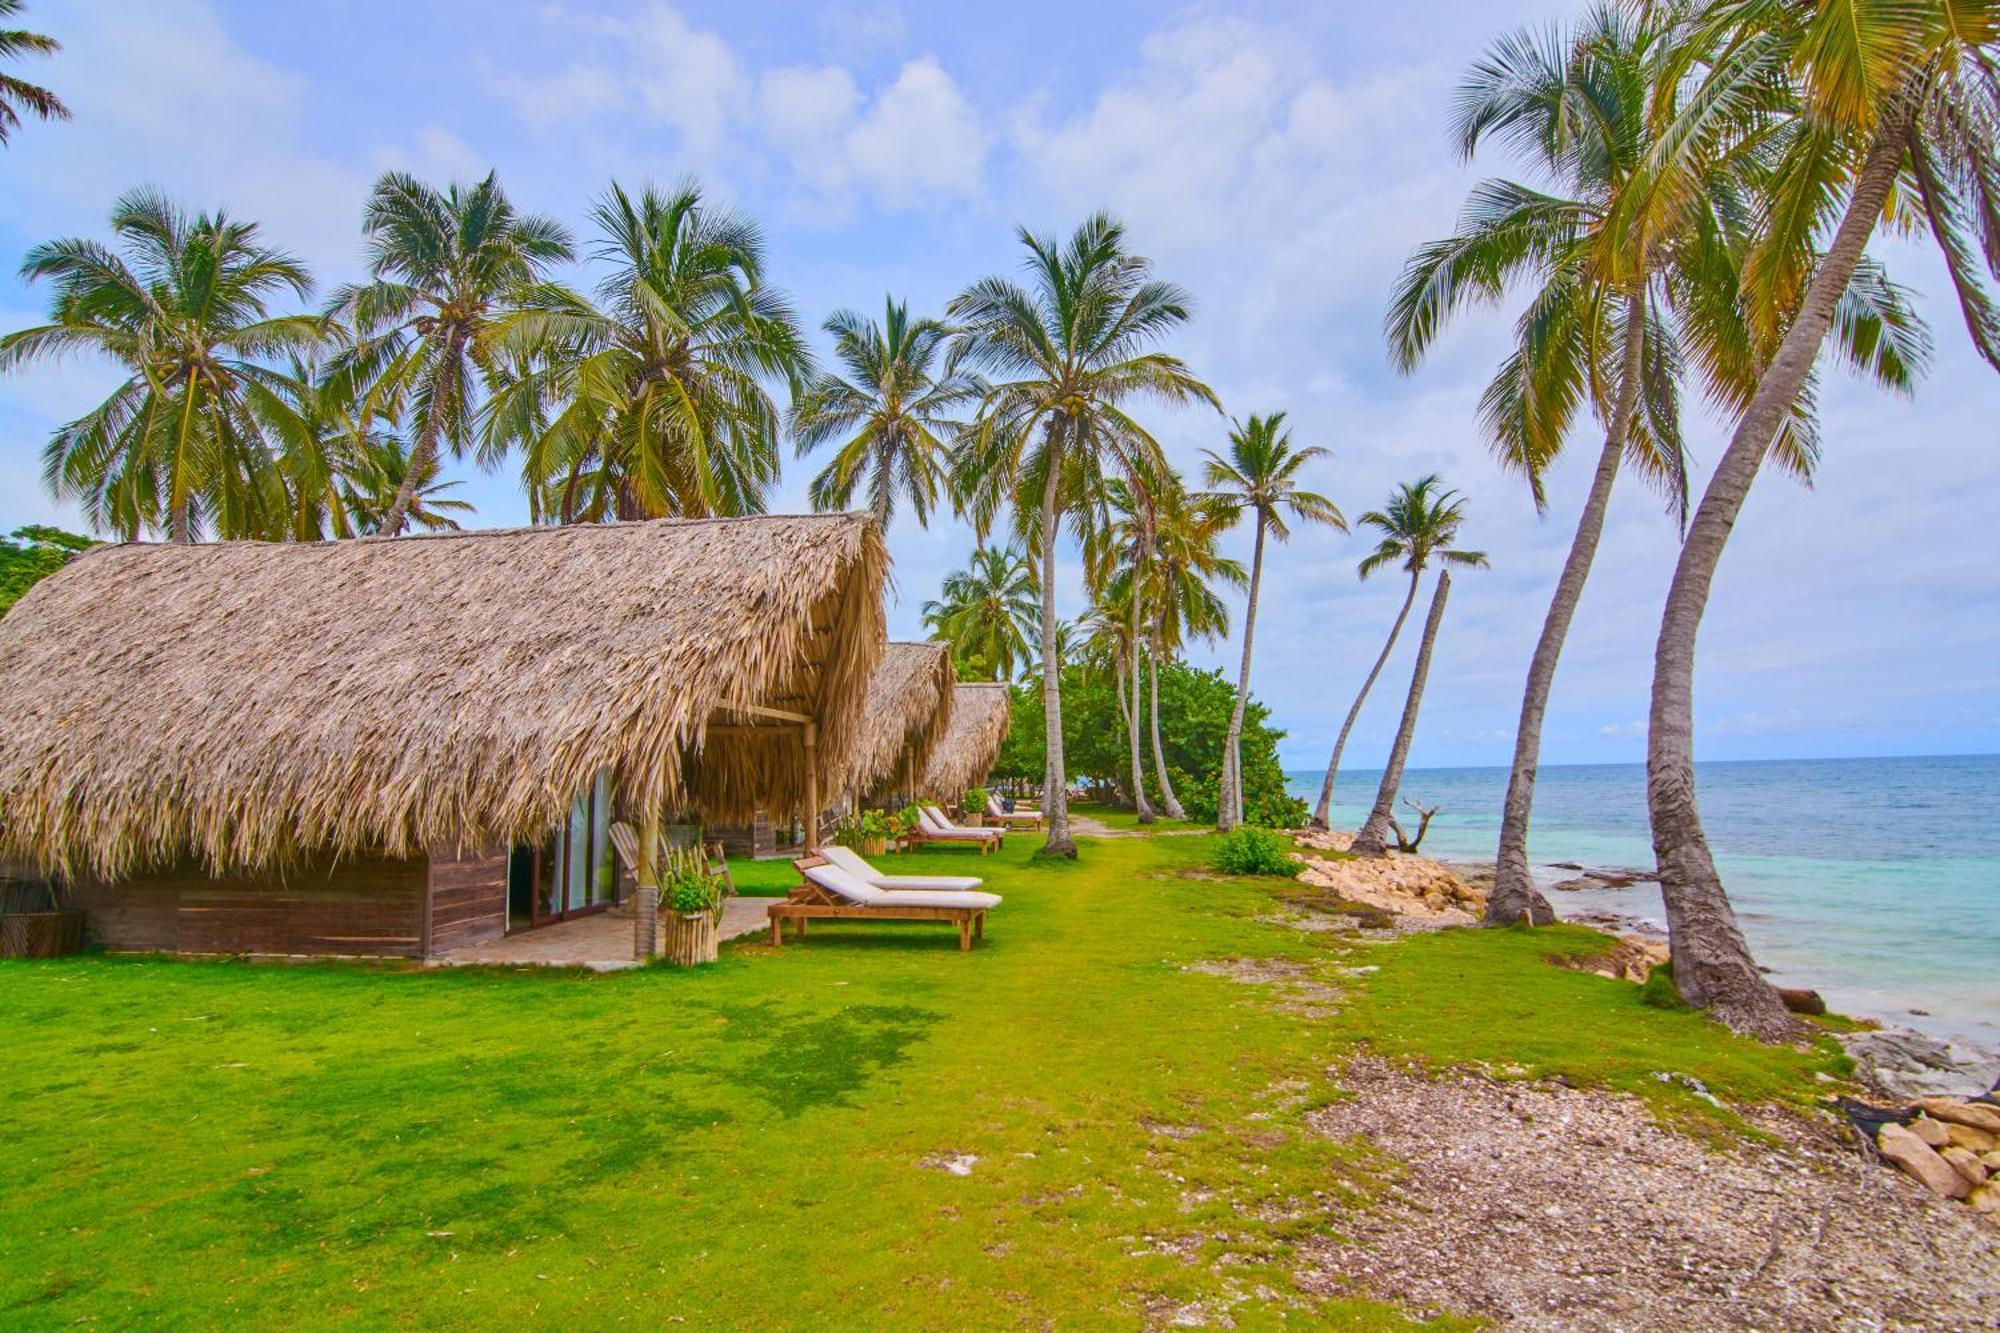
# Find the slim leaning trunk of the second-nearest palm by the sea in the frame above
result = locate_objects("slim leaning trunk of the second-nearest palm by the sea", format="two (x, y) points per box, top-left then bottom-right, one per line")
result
(1486, 292), (1646, 925)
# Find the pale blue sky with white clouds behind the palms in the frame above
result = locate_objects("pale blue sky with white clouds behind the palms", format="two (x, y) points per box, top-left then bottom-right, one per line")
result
(0, 0), (2000, 769)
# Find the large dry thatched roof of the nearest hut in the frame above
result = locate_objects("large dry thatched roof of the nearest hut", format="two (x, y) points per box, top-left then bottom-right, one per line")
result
(0, 514), (888, 875)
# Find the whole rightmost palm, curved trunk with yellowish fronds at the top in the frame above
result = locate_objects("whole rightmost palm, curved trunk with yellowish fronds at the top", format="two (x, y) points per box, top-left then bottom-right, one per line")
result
(1646, 0), (2000, 1035)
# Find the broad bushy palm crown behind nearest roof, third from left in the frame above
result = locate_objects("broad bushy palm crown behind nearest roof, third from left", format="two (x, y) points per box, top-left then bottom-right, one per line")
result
(488, 180), (812, 522)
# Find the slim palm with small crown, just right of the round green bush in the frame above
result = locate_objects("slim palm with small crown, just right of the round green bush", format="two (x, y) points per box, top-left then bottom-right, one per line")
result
(1202, 412), (1348, 831)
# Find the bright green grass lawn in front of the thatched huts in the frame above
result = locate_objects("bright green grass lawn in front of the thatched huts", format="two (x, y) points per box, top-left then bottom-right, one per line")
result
(0, 837), (1830, 1329)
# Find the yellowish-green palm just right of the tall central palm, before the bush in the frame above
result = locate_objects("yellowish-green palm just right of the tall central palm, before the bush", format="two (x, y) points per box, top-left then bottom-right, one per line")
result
(1144, 466), (1246, 819)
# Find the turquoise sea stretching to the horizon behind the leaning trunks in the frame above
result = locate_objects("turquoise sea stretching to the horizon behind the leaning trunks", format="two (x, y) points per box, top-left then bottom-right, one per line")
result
(1286, 755), (2000, 1047)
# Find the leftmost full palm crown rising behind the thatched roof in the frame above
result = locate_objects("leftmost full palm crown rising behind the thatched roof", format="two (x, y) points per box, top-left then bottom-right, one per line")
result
(0, 190), (318, 542)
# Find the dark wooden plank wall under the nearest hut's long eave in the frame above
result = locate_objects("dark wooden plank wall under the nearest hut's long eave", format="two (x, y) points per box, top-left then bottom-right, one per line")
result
(72, 857), (428, 959)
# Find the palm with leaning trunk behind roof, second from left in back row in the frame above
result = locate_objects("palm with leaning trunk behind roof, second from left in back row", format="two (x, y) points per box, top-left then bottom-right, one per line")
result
(328, 172), (572, 536)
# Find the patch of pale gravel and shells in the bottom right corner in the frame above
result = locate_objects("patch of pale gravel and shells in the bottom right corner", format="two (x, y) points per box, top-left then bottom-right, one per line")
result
(1300, 1061), (2000, 1329)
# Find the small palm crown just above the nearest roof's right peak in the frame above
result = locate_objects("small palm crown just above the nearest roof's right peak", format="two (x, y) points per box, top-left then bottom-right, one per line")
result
(792, 298), (980, 528)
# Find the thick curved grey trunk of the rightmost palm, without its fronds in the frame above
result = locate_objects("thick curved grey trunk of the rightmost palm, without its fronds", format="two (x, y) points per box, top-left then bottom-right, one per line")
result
(1646, 96), (1912, 1037)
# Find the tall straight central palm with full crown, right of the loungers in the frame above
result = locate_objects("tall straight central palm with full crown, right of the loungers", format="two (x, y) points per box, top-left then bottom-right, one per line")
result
(948, 214), (1222, 857)
